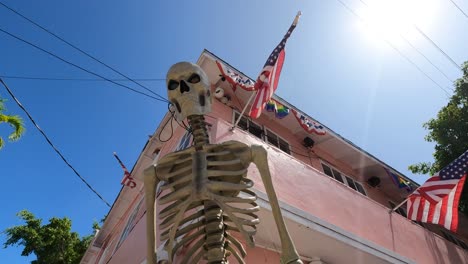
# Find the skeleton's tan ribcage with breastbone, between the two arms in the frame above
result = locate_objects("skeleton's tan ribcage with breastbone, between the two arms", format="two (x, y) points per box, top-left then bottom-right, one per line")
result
(157, 142), (259, 263)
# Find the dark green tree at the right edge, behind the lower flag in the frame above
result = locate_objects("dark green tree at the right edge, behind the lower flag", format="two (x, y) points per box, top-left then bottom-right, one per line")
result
(409, 61), (468, 215)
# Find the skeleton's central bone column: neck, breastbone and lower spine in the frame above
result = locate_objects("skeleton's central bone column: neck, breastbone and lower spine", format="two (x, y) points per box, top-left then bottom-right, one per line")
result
(188, 115), (228, 264)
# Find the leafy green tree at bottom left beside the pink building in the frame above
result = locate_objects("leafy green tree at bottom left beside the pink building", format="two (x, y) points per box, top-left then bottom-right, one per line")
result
(4, 210), (93, 264)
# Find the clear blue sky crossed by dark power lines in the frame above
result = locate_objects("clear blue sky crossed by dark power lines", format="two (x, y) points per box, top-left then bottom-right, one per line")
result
(0, 0), (468, 263)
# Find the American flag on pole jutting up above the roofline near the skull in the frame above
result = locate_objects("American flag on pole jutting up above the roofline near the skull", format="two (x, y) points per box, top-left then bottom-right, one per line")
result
(249, 11), (301, 118)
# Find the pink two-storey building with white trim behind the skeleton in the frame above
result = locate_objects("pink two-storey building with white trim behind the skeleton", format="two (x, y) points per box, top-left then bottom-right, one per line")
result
(81, 50), (468, 264)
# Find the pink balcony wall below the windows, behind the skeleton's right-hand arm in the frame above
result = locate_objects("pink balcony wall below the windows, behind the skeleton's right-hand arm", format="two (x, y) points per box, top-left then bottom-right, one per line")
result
(213, 120), (467, 264)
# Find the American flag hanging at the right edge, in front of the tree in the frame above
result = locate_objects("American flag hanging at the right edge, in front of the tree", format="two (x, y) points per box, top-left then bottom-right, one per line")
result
(407, 151), (468, 232)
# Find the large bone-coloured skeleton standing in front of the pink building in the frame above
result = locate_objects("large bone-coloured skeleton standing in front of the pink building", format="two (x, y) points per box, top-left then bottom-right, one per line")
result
(144, 62), (302, 264)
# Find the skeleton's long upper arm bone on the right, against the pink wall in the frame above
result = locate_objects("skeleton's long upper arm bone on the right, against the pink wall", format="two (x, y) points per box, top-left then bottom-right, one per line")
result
(251, 145), (302, 264)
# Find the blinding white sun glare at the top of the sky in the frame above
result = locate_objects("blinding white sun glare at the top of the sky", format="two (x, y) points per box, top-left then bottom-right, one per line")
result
(359, 0), (437, 44)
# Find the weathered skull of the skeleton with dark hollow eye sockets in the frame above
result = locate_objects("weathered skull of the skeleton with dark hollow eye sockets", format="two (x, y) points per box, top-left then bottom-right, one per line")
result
(166, 62), (211, 121)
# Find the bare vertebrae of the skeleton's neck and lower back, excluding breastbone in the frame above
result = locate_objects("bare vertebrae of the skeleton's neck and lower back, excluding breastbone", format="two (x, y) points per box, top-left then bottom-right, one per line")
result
(187, 115), (228, 264)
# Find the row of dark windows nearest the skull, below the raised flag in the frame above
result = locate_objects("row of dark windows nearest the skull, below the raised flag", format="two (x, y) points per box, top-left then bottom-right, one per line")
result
(234, 112), (291, 154)
